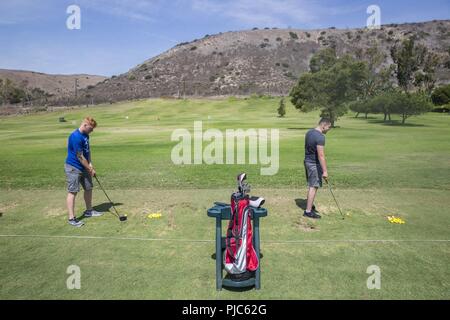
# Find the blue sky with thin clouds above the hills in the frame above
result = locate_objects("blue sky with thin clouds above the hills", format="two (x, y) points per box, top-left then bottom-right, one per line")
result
(0, 0), (450, 76)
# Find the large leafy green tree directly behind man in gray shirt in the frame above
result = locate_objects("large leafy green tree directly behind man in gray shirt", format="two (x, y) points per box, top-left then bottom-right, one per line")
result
(290, 48), (368, 126)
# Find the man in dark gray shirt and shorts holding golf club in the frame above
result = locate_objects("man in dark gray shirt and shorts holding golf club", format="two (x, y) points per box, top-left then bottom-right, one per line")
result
(303, 118), (331, 219)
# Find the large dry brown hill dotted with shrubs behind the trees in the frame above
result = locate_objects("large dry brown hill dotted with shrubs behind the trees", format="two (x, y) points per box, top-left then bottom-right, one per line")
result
(70, 20), (450, 103)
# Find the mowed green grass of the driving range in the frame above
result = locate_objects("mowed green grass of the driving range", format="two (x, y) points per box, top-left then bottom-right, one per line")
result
(0, 99), (450, 299)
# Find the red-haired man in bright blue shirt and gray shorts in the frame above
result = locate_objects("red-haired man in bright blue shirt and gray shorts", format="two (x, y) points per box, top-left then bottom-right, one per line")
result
(64, 117), (103, 227)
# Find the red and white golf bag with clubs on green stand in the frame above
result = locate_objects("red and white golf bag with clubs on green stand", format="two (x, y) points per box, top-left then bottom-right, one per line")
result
(224, 173), (264, 281)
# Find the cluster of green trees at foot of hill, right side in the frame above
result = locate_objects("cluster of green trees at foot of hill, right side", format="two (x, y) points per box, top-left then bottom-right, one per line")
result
(289, 37), (450, 126)
